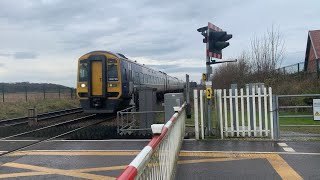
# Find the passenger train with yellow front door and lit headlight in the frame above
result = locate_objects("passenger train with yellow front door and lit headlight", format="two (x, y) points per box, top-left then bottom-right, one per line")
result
(76, 51), (185, 113)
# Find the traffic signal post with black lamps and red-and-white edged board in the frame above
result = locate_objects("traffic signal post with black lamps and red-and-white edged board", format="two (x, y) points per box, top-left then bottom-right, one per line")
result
(197, 22), (237, 135)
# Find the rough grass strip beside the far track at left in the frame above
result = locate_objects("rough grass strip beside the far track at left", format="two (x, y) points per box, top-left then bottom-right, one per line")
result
(0, 99), (80, 119)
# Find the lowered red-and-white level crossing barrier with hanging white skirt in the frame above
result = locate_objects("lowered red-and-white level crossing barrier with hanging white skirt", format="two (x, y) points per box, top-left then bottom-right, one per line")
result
(117, 103), (186, 180)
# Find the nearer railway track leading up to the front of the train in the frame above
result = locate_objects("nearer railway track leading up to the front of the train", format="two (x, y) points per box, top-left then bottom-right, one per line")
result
(0, 114), (116, 157)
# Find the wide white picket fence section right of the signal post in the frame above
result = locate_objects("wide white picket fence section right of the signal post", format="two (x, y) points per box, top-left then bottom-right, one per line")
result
(215, 87), (273, 139)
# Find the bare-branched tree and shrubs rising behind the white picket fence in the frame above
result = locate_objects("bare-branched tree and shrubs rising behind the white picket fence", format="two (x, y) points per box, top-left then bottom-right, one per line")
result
(213, 26), (285, 88)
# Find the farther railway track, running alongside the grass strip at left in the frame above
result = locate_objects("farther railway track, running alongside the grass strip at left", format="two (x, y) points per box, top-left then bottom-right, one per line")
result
(0, 107), (83, 128)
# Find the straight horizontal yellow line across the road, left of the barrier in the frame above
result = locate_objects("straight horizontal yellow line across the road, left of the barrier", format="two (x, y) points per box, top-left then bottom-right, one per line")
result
(8, 151), (140, 156)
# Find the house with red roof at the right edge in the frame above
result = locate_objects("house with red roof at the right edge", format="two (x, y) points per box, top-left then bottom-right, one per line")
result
(304, 30), (320, 72)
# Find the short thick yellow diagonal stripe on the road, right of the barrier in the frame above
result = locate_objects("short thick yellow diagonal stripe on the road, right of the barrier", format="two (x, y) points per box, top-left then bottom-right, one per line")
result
(267, 154), (303, 180)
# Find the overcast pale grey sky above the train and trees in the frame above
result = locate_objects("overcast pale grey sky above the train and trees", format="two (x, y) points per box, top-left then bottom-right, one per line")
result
(0, 0), (320, 87)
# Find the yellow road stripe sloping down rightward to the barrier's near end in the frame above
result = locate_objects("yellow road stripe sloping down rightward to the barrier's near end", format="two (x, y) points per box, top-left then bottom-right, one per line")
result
(2, 163), (115, 179)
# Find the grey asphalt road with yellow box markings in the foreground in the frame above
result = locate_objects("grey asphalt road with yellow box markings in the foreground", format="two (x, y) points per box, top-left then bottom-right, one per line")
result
(0, 140), (320, 179)
